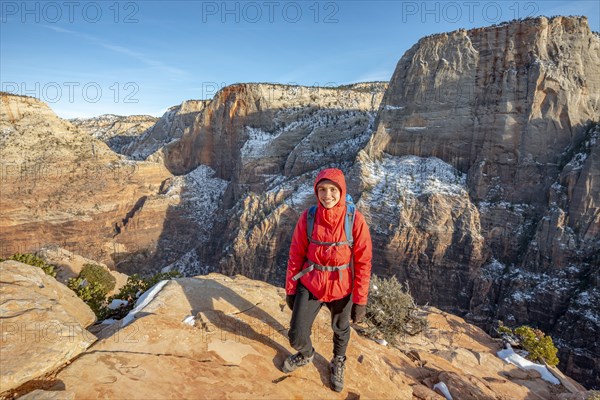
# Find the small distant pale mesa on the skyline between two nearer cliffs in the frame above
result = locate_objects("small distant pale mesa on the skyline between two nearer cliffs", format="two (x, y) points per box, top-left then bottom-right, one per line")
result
(69, 114), (158, 153)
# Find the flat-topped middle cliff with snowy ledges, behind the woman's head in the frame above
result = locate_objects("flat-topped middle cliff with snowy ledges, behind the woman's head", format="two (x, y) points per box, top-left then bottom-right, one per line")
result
(163, 84), (385, 183)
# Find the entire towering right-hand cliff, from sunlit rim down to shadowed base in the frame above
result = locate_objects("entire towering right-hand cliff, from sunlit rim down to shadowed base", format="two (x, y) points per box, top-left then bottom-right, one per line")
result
(358, 17), (600, 385)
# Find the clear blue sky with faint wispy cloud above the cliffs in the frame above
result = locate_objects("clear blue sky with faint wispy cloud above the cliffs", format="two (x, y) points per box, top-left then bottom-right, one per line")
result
(0, 0), (600, 118)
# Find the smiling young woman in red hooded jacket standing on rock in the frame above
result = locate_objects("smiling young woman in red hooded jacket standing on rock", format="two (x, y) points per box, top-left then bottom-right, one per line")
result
(282, 168), (372, 392)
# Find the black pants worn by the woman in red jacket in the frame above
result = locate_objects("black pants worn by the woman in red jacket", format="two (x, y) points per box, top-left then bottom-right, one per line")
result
(288, 282), (352, 357)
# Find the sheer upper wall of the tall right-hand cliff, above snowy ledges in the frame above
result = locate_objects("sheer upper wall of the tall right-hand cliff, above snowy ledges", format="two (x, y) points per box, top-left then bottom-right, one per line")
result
(369, 17), (600, 204)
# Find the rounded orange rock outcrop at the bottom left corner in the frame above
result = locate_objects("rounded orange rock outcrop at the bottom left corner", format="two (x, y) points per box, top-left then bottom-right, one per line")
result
(0, 261), (96, 392)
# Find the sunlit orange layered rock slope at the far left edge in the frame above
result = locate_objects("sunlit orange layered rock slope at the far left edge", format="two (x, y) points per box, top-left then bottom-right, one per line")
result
(0, 93), (172, 268)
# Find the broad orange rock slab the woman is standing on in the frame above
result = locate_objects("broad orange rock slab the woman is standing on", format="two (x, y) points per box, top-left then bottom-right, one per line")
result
(28, 274), (575, 400)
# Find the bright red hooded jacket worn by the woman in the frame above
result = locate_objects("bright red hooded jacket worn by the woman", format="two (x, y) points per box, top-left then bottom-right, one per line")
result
(285, 168), (372, 304)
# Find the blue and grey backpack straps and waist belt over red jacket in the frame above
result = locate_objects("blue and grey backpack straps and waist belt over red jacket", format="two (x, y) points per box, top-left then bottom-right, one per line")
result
(292, 194), (356, 281)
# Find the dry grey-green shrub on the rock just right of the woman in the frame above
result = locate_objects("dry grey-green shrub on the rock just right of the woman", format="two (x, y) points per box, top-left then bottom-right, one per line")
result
(365, 275), (427, 344)
